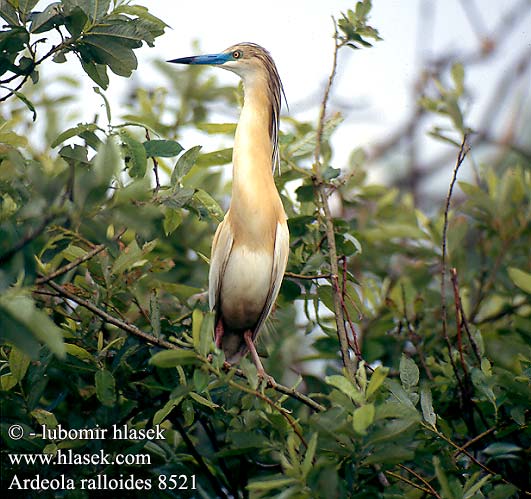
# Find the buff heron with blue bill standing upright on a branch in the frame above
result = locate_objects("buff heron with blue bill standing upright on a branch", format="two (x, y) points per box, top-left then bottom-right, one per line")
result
(168, 42), (289, 383)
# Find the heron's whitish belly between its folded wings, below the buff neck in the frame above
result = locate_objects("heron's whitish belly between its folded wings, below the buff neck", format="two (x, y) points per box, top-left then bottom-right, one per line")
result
(220, 245), (273, 329)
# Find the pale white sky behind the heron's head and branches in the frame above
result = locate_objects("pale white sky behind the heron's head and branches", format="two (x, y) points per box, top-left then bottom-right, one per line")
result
(35, 0), (531, 193)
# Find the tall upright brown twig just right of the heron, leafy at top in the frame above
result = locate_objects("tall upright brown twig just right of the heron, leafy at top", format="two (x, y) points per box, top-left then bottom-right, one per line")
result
(312, 20), (356, 379)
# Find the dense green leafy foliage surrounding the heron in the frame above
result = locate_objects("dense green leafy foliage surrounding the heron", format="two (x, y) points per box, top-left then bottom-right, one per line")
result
(0, 0), (531, 499)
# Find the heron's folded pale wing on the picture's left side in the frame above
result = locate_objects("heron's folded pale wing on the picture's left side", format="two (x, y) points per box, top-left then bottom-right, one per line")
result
(208, 212), (234, 310)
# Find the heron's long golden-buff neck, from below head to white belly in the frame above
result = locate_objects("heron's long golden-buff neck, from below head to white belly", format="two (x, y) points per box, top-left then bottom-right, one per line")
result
(231, 76), (283, 248)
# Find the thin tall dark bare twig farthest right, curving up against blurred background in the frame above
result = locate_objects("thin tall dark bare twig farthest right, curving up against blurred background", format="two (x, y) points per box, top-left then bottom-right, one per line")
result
(441, 134), (469, 402)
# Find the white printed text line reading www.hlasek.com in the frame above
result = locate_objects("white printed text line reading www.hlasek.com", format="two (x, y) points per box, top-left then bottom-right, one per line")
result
(9, 449), (151, 466)
